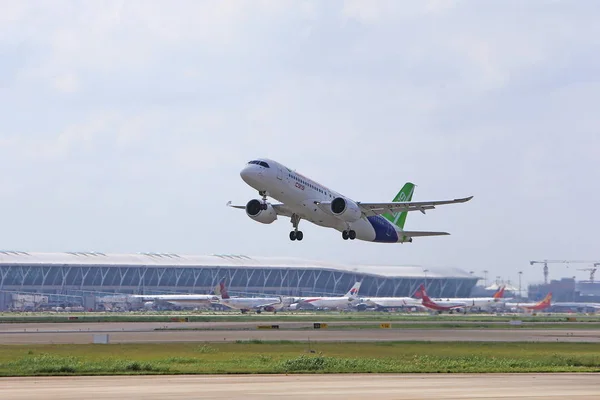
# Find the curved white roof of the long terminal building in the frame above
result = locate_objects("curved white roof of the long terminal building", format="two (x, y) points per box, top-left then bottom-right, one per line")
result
(0, 251), (477, 279)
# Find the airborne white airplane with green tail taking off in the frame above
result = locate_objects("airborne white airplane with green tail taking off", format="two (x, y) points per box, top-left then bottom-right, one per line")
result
(227, 158), (473, 243)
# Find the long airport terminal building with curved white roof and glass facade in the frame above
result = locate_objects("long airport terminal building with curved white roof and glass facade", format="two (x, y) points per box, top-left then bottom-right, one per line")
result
(0, 251), (478, 310)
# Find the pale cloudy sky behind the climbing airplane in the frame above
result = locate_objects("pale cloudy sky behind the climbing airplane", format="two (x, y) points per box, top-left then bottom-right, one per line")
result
(0, 0), (600, 292)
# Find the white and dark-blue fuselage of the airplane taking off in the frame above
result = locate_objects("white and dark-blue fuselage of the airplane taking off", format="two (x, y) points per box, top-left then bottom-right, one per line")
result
(240, 159), (404, 243)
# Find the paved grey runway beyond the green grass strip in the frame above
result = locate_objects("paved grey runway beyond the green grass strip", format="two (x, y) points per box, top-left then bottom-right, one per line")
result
(0, 321), (600, 344)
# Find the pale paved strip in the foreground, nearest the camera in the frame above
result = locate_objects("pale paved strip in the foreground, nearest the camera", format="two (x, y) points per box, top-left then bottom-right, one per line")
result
(0, 374), (600, 400)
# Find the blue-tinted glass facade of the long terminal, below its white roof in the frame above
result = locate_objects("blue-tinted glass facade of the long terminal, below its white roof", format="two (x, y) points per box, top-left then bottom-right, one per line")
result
(0, 264), (477, 297)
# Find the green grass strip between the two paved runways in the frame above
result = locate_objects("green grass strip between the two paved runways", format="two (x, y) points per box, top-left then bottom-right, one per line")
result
(0, 340), (600, 376)
